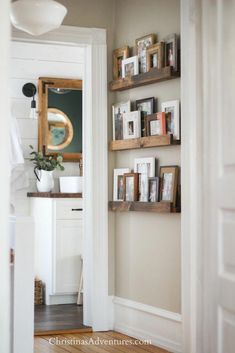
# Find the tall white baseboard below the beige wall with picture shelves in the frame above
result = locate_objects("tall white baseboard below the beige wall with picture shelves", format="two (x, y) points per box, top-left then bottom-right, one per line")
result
(113, 297), (182, 353)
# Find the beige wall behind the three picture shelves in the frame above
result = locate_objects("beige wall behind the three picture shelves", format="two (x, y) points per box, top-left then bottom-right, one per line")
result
(57, 0), (181, 312)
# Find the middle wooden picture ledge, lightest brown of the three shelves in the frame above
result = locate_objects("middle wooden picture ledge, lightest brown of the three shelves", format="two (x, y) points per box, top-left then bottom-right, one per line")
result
(109, 135), (180, 151)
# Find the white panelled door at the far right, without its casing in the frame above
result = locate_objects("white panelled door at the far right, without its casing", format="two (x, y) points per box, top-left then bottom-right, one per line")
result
(202, 0), (235, 353)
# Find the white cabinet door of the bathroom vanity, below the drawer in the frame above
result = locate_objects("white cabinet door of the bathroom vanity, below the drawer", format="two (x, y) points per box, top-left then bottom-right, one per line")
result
(53, 220), (82, 294)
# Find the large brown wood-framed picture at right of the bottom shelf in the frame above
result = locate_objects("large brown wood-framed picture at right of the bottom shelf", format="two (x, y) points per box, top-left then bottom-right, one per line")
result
(160, 166), (179, 207)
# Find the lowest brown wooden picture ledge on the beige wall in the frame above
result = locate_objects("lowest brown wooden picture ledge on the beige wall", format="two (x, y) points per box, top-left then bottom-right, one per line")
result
(109, 201), (180, 213)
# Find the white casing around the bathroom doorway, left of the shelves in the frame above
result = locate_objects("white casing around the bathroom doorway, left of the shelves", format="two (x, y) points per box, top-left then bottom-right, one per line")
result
(13, 26), (109, 330)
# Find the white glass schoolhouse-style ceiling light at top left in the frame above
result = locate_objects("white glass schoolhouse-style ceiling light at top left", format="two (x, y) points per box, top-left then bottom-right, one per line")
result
(10, 0), (67, 36)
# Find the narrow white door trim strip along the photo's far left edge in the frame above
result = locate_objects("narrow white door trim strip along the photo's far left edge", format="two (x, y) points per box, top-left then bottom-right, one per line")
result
(0, 0), (12, 353)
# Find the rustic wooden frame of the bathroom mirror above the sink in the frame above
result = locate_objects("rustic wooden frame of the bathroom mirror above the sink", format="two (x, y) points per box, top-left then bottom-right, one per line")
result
(38, 77), (83, 162)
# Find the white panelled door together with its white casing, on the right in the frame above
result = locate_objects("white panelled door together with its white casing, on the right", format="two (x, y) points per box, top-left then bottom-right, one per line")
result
(181, 0), (235, 353)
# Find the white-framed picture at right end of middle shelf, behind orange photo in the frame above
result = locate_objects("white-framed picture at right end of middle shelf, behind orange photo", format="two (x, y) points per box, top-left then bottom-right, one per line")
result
(162, 100), (180, 140)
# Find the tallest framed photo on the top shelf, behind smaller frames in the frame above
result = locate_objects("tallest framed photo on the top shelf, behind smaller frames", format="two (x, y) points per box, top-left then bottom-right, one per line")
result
(135, 33), (156, 73)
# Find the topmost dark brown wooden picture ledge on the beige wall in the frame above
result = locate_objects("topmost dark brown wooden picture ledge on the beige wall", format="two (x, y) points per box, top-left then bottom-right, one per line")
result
(109, 66), (180, 91)
